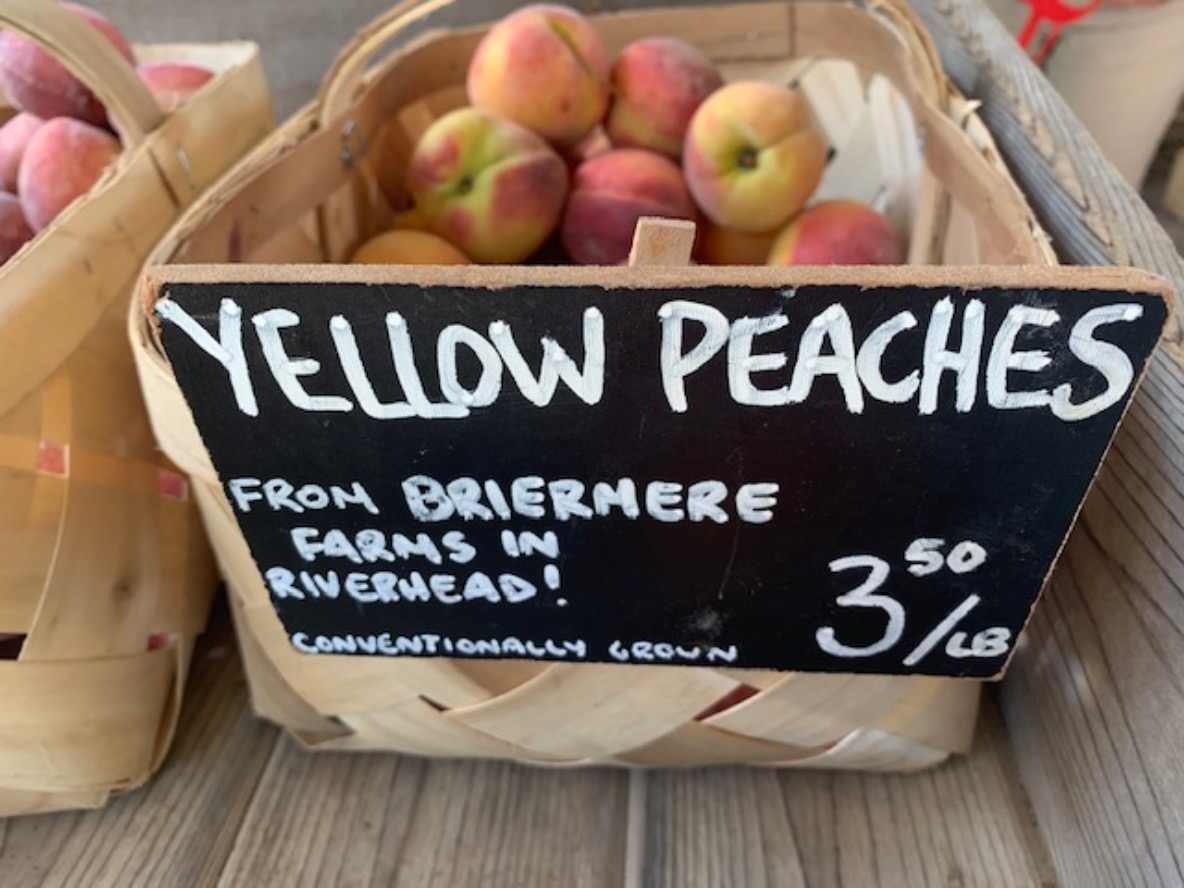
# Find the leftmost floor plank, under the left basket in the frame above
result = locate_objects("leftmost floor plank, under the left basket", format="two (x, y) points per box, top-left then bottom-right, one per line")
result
(0, 599), (278, 888)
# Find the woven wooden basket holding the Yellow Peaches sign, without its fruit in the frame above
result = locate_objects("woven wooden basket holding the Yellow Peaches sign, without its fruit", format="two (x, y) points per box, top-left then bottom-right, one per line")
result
(129, 0), (1054, 770)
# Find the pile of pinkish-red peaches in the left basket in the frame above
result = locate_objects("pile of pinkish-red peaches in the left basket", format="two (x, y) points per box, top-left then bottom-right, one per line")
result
(0, 4), (213, 263)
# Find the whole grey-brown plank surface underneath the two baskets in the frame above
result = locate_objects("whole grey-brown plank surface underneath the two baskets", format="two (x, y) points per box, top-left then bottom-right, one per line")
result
(0, 599), (1049, 888)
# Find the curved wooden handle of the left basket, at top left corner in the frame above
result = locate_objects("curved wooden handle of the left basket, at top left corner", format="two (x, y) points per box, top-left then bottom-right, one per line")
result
(0, 0), (165, 146)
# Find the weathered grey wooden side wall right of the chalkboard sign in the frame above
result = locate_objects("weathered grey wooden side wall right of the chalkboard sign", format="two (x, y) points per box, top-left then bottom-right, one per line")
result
(918, 0), (1184, 886)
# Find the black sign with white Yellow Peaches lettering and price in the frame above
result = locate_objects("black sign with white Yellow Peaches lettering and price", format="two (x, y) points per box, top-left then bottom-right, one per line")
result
(149, 260), (1169, 677)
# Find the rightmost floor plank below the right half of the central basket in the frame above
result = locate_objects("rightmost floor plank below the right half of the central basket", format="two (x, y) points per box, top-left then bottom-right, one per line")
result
(635, 699), (1051, 888)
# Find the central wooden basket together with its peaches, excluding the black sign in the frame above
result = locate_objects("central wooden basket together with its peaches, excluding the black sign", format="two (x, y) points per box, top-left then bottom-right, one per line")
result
(129, 0), (1054, 770)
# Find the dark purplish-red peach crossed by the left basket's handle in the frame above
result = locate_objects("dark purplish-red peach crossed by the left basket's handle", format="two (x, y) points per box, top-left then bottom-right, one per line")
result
(0, 2), (134, 127)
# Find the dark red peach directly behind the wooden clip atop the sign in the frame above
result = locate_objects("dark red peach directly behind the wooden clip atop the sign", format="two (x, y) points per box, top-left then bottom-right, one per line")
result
(560, 148), (697, 265)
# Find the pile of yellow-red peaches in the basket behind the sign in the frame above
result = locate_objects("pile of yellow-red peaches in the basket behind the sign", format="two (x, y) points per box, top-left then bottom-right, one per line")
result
(352, 4), (905, 265)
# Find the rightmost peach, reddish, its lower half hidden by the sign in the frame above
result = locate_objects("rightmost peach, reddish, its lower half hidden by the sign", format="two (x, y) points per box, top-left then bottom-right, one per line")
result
(768, 200), (905, 265)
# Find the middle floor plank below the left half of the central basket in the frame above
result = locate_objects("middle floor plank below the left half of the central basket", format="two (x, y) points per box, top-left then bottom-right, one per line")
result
(219, 739), (628, 888)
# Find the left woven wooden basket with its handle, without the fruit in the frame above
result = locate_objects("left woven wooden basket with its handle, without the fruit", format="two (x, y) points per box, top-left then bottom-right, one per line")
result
(0, 0), (272, 816)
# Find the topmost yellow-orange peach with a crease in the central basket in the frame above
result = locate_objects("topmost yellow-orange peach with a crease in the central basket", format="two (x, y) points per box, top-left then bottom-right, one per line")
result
(465, 4), (609, 148)
